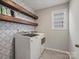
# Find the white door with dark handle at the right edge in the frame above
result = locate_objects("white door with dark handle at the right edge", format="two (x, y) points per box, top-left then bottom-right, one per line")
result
(69, 0), (79, 59)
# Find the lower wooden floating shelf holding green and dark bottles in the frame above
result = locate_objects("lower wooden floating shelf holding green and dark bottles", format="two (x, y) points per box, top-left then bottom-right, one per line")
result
(0, 14), (38, 26)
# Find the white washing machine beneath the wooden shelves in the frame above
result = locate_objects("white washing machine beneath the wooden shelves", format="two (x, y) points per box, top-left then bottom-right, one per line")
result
(15, 32), (45, 59)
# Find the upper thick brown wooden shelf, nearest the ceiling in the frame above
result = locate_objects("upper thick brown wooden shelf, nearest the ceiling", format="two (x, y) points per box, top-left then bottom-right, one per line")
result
(0, 0), (38, 19)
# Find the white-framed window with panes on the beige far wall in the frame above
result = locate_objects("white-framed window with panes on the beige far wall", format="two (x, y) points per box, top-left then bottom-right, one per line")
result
(52, 9), (68, 30)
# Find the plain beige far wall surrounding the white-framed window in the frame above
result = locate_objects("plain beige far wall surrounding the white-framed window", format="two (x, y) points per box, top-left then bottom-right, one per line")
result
(36, 4), (69, 51)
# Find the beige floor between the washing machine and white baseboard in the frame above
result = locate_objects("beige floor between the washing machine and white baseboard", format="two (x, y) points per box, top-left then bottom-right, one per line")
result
(40, 50), (69, 59)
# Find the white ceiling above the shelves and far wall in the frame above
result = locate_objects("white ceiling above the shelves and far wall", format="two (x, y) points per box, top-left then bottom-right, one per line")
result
(24, 0), (69, 10)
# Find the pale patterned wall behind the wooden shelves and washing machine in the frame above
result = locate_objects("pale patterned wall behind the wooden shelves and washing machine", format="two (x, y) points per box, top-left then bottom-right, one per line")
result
(0, 0), (34, 59)
